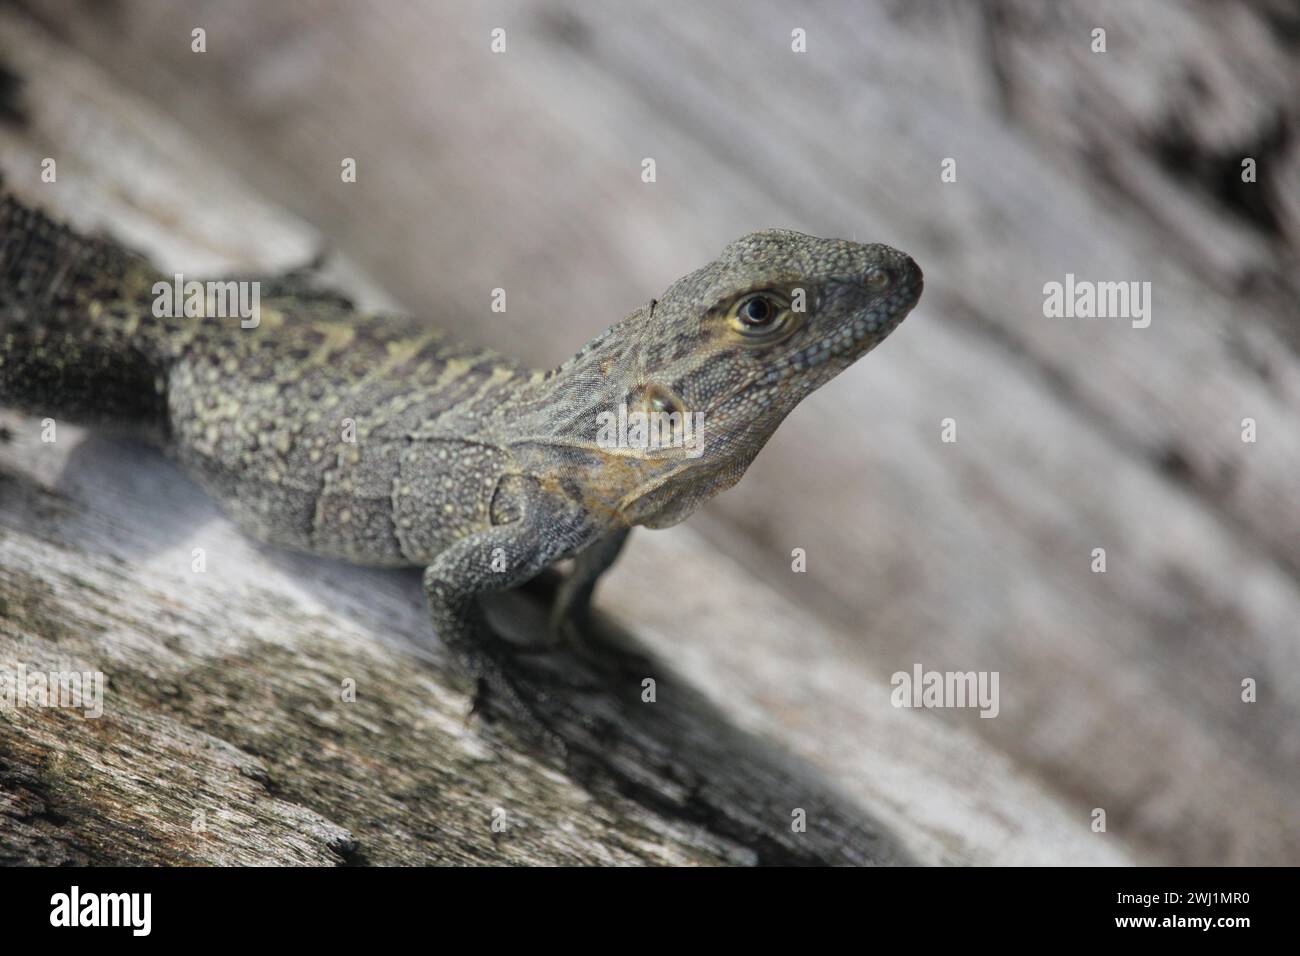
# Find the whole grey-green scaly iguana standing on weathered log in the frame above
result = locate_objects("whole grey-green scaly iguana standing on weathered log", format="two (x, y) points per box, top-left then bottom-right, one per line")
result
(0, 198), (922, 749)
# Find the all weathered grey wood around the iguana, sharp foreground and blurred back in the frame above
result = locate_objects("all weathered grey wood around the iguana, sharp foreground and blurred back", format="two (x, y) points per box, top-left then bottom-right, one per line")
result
(0, 0), (1300, 864)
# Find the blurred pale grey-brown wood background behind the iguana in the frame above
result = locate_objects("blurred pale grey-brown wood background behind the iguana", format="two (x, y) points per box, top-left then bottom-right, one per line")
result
(0, 0), (1300, 864)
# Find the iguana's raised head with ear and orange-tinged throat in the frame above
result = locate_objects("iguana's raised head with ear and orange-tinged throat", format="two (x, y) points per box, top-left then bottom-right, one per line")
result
(540, 229), (922, 528)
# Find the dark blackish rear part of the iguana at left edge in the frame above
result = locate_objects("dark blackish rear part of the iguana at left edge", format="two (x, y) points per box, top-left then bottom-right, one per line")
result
(0, 195), (166, 432)
